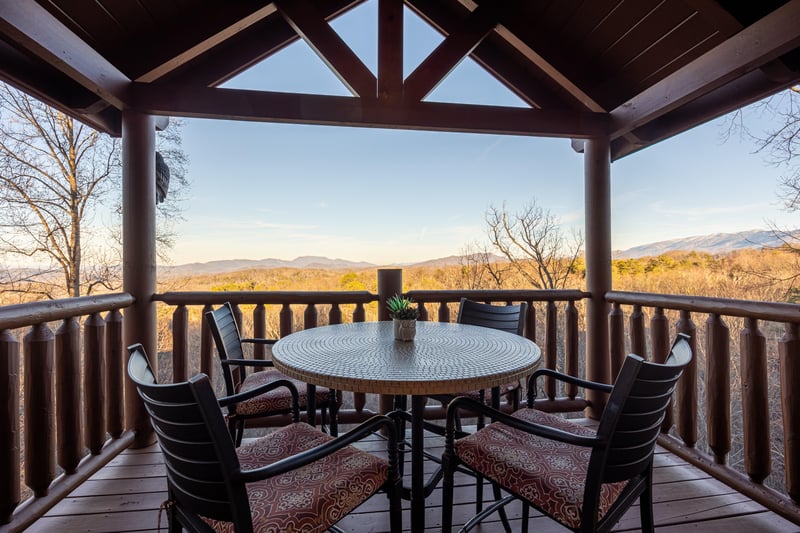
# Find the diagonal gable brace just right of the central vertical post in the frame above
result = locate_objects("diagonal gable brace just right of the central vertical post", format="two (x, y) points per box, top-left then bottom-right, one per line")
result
(403, 4), (498, 101)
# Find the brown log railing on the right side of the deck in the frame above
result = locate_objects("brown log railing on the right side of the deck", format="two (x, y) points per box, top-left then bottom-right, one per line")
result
(606, 292), (800, 523)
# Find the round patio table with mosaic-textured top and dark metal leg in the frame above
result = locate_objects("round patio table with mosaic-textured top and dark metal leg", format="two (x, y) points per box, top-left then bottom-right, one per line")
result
(272, 321), (541, 531)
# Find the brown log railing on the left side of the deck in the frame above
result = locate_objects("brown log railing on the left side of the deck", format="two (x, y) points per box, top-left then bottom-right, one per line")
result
(0, 294), (134, 531)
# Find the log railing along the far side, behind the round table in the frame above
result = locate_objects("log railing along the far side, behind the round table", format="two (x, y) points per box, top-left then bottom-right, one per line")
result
(155, 286), (586, 424)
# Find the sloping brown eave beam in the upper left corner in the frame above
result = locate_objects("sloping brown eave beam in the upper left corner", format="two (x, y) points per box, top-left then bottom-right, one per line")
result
(0, 0), (131, 109)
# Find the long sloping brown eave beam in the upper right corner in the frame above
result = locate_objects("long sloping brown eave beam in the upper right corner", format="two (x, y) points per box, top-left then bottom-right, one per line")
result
(611, 0), (800, 138)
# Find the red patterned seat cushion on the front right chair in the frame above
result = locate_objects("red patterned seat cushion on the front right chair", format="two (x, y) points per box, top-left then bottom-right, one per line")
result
(455, 409), (625, 528)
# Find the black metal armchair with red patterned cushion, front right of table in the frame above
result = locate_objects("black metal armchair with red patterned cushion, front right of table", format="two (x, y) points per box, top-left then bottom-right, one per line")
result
(442, 334), (692, 531)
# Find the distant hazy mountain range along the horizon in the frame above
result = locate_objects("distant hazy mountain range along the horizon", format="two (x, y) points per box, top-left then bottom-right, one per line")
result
(159, 230), (782, 276)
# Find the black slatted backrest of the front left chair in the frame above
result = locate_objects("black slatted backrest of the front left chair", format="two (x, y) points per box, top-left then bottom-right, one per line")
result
(128, 344), (252, 531)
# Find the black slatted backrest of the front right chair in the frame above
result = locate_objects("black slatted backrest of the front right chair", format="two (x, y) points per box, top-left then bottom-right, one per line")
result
(584, 334), (692, 523)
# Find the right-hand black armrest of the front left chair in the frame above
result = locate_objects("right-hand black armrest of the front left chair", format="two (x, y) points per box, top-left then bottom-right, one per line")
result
(236, 415), (397, 483)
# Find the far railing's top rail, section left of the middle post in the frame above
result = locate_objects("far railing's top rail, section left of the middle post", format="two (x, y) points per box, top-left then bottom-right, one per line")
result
(159, 291), (378, 305)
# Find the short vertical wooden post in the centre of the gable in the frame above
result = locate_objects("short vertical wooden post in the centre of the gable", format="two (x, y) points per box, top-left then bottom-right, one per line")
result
(378, 0), (403, 101)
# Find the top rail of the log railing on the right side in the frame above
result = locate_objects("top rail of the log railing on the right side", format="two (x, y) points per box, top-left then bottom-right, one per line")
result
(606, 291), (800, 323)
